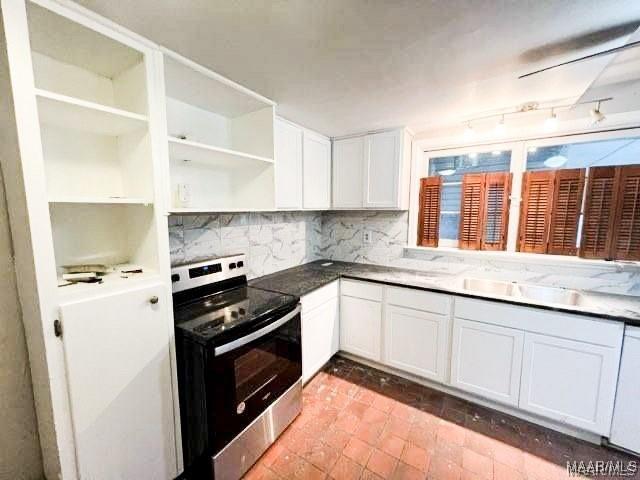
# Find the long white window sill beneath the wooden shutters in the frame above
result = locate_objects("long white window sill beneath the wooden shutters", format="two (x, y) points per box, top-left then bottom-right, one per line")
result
(405, 247), (640, 273)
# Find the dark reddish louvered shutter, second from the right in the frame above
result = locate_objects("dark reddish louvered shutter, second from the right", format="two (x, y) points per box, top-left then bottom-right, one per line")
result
(580, 167), (617, 258)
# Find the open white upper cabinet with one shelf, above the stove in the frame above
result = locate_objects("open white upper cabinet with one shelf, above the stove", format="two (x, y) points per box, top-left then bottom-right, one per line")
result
(164, 52), (275, 213)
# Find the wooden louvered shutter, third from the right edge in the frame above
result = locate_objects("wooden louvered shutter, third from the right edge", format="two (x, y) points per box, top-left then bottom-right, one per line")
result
(547, 168), (585, 255)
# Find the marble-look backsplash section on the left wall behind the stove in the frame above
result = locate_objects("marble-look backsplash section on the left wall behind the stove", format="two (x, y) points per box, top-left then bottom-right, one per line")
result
(169, 212), (322, 278)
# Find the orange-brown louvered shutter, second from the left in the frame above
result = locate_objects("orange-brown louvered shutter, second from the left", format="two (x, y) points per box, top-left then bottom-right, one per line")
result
(458, 173), (485, 250)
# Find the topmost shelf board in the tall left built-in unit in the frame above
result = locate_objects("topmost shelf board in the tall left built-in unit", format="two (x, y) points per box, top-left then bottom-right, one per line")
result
(35, 88), (148, 136)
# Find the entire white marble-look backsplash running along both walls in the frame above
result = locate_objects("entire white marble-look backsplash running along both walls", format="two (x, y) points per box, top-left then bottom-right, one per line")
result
(169, 211), (640, 296)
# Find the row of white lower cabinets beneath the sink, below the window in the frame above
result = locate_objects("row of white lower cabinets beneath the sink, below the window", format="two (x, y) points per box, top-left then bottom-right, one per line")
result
(336, 280), (624, 436)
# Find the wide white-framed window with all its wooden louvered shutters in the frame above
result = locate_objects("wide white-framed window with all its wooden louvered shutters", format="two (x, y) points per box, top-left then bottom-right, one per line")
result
(411, 129), (640, 260)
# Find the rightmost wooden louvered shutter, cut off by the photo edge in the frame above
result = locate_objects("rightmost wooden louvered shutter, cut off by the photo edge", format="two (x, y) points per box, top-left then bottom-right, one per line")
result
(611, 165), (640, 260)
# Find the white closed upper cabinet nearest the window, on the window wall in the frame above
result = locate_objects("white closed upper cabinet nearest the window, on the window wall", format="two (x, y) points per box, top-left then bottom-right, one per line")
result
(333, 129), (411, 210)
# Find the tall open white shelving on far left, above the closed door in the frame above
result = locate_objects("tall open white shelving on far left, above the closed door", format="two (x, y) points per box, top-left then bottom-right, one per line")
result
(27, 3), (159, 284)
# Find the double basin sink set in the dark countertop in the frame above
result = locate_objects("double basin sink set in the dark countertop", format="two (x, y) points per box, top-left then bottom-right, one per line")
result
(452, 278), (593, 307)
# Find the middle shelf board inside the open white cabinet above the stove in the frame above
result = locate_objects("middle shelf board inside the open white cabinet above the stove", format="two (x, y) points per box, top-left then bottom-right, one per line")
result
(169, 136), (274, 168)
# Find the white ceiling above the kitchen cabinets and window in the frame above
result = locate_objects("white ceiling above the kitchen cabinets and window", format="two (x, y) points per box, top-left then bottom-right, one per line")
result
(79, 0), (640, 136)
